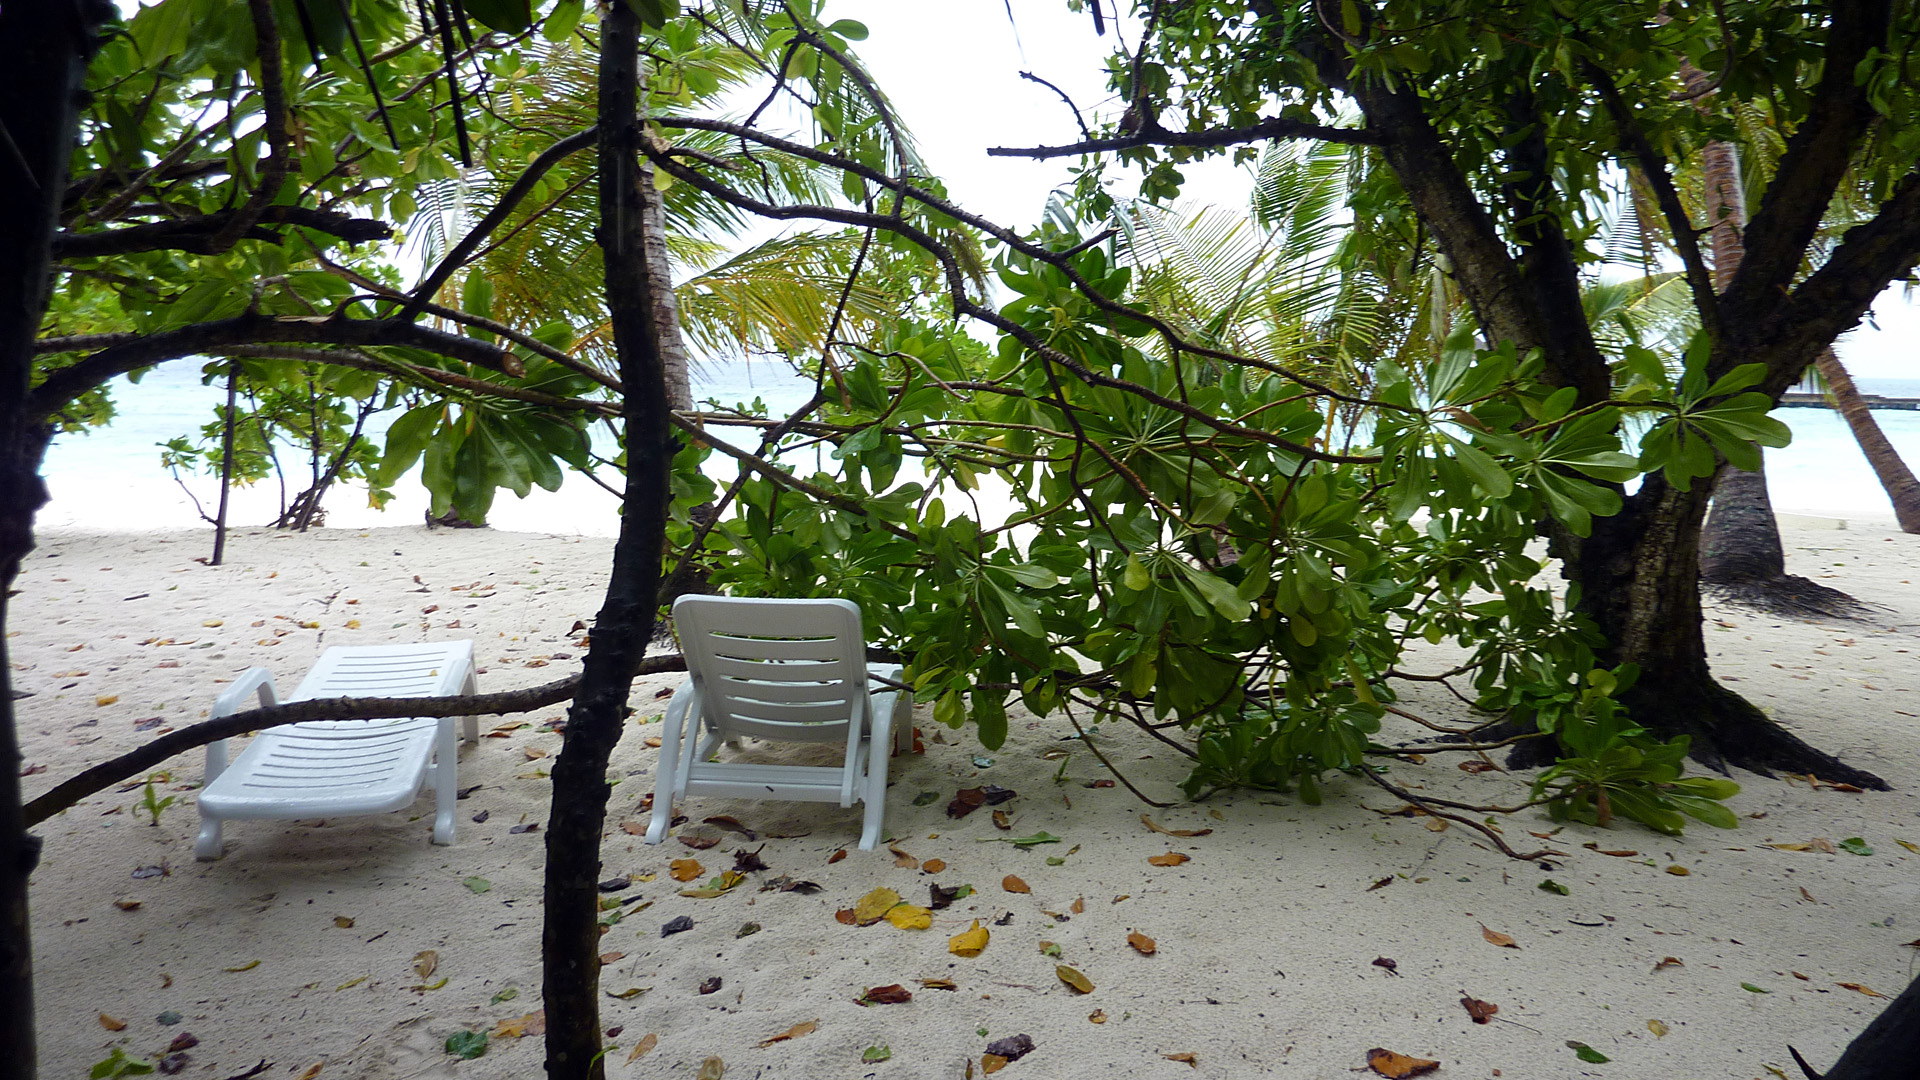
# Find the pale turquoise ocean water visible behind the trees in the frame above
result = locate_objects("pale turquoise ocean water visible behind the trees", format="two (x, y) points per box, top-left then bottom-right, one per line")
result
(38, 361), (1920, 536)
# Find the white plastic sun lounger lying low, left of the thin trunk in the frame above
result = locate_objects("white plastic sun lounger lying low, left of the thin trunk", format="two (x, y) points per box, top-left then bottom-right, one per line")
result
(194, 642), (480, 859)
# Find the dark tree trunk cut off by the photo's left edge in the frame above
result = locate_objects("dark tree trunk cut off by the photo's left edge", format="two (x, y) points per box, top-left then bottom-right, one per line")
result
(0, 0), (113, 1076)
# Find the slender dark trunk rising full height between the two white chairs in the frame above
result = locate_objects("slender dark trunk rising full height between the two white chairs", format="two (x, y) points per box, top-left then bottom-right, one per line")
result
(541, 4), (674, 1080)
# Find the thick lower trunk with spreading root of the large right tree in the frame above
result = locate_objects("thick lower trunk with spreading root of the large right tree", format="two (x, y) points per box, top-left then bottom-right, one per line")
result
(1543, 473), (1887, 792)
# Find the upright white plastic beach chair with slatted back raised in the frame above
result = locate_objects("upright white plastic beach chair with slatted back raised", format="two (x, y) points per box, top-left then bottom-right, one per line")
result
(647, 596), (914, 851)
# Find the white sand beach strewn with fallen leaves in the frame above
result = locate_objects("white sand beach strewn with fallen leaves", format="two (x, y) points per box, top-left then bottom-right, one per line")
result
(10, 521), (1920, 1080)
